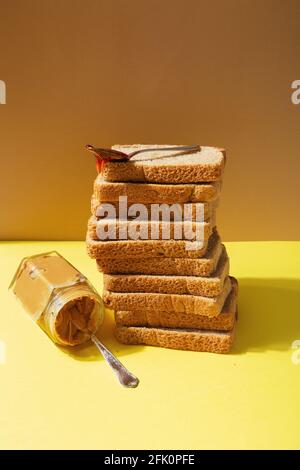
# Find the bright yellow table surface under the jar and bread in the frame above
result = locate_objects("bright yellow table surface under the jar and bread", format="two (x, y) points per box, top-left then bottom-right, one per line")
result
(0, 242), (300, 449)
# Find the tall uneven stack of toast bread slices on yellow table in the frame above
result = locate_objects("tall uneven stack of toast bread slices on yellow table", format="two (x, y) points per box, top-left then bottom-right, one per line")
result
(87, 145), (237, 353)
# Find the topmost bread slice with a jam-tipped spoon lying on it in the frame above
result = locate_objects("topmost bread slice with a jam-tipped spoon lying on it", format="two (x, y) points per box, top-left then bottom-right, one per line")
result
(102, 144), (225, 184)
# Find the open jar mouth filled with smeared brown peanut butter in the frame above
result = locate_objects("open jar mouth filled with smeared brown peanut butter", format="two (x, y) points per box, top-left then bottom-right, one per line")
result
(55, 296), (99, 346)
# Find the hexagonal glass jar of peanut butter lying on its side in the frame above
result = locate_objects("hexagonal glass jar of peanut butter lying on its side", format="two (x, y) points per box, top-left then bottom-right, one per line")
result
(10, 251), (104, 346)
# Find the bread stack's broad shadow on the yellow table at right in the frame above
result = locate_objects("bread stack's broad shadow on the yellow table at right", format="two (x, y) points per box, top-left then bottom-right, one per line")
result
(232, 279), (300, 354)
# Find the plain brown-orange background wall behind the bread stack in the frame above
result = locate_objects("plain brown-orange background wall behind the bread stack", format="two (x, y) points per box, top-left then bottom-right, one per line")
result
(0, 0), (300, 240)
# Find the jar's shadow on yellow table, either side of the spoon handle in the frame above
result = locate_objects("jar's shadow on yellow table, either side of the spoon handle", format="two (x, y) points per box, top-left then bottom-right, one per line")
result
(60, 310), (144, 361)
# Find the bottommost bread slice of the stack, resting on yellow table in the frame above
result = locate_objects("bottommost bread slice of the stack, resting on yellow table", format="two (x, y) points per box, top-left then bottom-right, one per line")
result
(115, 320), (236, 354)
